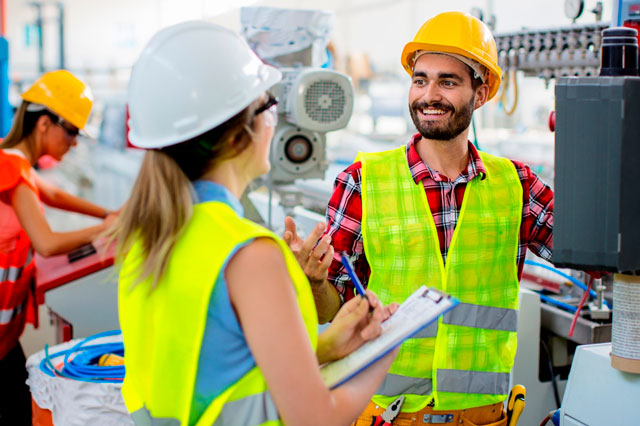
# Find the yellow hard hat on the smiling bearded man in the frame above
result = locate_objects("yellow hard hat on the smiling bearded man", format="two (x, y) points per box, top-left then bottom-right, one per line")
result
(400, 12), (502, 99)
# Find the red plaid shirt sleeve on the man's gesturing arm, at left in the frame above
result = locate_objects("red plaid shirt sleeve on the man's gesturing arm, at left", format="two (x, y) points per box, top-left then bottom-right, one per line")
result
(325, 162), (371, 303)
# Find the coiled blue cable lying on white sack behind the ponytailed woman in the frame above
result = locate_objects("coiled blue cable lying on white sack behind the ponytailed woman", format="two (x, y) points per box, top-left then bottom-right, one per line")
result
(40, 330), (125, 383)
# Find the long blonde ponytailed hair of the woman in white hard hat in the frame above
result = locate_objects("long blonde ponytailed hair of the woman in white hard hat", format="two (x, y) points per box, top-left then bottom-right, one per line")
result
(113, 101), (257, 290)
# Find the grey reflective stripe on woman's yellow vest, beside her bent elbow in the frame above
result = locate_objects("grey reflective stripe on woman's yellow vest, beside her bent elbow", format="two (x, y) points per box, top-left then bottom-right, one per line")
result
(213, 392), (280, 426)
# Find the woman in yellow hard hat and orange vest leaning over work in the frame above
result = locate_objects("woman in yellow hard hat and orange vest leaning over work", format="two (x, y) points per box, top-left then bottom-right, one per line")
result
(0, 70), (115, 425)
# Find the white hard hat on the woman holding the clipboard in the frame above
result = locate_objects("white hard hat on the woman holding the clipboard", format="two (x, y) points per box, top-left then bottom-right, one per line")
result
(128, 21), (282, 148)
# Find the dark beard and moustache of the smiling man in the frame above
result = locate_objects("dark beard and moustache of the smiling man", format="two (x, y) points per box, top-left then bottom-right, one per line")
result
(409, 95), (475, 141)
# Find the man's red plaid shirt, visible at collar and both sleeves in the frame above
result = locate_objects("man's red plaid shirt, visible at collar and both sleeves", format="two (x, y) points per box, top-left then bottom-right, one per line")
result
(325, 134), (553, 300)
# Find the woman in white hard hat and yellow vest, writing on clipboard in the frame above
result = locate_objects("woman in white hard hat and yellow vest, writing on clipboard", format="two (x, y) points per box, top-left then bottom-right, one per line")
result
(117, 22), (395, 426)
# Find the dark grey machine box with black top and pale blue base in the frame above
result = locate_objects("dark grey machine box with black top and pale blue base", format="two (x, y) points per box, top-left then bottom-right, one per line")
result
(554, 24), (640, 425)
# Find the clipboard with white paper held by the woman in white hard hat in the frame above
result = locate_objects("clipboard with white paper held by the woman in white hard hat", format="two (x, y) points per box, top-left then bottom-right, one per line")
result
(320, 285), (458, 389)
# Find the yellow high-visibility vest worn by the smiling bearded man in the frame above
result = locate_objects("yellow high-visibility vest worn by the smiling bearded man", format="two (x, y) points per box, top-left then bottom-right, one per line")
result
(356, 147), (522, 412)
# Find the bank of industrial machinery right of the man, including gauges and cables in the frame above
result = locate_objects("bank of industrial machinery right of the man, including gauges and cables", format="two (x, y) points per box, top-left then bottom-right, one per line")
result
(496, 0), (640, 426)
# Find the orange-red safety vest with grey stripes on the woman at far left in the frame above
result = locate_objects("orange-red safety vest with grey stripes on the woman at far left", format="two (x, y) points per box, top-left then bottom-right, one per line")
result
(0, 150), (39, 359)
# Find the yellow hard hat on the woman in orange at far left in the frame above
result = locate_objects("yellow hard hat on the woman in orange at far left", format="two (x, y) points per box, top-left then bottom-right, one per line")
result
(22, 70), (93, 129)
